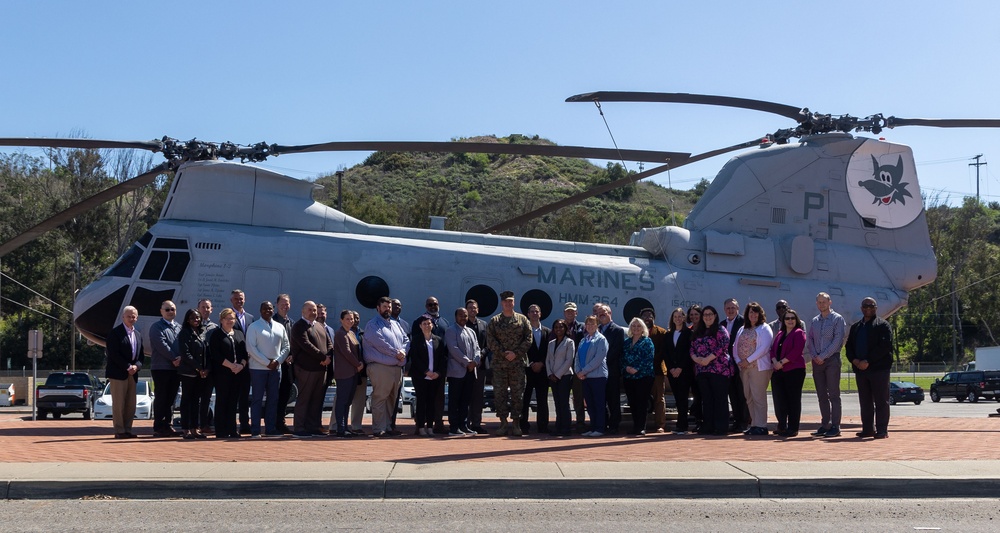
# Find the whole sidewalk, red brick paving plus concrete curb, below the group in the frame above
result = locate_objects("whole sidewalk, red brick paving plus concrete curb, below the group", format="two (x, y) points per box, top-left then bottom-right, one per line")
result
(0, 413), (1000, 499)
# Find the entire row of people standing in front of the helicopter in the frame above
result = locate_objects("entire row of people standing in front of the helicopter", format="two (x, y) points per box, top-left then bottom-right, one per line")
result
(107, 290), (892, 439)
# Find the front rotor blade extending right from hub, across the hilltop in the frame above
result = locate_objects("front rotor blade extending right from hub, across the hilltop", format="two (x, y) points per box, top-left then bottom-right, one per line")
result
(272, 141), (691, 163)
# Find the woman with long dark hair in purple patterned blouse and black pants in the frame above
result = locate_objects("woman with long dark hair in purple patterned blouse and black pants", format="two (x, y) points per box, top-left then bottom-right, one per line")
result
(691, 305), (733, 435)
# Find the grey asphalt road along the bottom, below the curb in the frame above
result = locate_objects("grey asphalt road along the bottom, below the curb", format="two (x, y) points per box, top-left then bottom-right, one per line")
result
(0, 499), (1000, 533)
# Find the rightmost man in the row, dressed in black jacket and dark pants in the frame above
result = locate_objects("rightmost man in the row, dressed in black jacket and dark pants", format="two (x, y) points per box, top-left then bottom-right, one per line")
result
(846, 297), (892, 439)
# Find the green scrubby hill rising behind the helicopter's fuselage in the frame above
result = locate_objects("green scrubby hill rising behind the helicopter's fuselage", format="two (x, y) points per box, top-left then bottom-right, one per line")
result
(315, 134), (695, 244)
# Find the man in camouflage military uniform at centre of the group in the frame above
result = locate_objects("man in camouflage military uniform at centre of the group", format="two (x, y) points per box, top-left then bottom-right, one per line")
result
(486, 291), (531, 437)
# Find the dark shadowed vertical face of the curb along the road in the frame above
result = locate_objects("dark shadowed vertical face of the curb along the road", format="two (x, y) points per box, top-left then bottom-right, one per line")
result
(3, 478), (1000, 500)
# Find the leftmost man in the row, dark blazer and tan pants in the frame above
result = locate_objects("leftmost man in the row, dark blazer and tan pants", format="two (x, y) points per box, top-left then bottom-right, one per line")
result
(105, 305), (145, 439)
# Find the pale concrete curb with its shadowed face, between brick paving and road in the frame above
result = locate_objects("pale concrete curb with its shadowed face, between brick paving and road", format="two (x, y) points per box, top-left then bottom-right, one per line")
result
(7, 461), (1000, 500)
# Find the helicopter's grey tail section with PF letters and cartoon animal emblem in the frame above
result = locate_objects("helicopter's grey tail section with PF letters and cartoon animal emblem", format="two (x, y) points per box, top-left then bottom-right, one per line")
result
(660, 134), (937, 298)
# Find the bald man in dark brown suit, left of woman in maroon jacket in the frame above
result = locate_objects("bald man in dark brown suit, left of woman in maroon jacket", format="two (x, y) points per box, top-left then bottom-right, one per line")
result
(289, 301), (333, 438)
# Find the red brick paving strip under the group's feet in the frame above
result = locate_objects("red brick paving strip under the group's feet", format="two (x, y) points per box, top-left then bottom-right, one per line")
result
(0, 415), (1000, 463)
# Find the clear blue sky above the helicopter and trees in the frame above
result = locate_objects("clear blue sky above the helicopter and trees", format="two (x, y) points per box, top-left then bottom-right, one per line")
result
(0, 0), (1000, 203)
